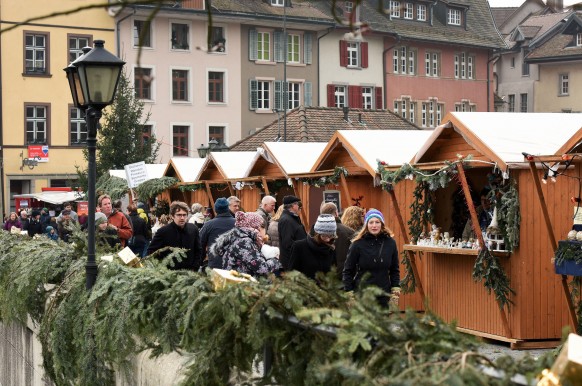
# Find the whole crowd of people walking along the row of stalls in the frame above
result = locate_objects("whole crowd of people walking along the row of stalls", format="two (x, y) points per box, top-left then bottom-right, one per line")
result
(3, 195), (400, 305)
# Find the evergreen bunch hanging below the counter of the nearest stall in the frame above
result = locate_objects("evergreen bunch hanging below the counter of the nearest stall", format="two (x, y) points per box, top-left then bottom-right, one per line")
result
(473, 248), (515, 309)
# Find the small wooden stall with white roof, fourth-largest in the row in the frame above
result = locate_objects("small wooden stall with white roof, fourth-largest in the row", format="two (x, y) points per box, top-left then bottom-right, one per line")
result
(195, 151), (260, 211)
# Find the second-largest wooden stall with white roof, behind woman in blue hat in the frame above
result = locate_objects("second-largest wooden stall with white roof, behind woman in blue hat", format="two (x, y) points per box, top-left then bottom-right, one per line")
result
(311, 130), (432, 310)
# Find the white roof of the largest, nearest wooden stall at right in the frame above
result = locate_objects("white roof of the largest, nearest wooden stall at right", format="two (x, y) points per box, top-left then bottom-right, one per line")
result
(414, 112), (582, 164)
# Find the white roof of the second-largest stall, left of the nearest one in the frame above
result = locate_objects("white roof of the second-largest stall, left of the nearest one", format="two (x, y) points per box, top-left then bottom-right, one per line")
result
(338, 130), (433, 173)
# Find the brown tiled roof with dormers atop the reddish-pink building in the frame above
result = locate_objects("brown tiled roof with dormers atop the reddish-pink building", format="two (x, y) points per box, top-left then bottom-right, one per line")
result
(313, 0), (505, 48)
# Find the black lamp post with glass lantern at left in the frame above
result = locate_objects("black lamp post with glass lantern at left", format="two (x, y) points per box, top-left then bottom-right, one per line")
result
(64, 40), (125, 290)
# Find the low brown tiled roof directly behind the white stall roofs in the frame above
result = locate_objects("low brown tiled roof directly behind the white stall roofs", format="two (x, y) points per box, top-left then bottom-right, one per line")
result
(230, 106), (420, 151)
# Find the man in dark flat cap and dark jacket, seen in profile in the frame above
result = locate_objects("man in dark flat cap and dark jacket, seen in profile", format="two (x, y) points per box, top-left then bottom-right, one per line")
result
(278, 196), (307, 271)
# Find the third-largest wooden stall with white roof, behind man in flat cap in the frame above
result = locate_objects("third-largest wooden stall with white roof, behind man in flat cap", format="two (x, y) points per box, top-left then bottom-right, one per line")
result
(245, 142), (326, 229)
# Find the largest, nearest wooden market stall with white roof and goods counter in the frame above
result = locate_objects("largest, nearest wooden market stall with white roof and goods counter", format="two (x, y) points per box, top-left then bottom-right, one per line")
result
(391, 112), (582, 348)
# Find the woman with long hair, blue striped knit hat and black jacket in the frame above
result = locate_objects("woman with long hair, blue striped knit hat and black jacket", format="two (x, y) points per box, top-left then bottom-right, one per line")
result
(342, 209), (400, 307)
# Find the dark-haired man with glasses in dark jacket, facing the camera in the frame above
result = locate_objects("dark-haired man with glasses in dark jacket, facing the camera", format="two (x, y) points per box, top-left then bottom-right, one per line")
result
(148, 201), (201, 271)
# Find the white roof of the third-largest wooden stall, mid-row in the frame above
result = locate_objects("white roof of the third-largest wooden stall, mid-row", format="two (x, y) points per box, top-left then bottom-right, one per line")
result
(264, 142), (327, 176)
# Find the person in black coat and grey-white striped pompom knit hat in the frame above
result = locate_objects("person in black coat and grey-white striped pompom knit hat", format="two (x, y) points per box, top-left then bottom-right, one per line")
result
(290, 214), (337, 279)
